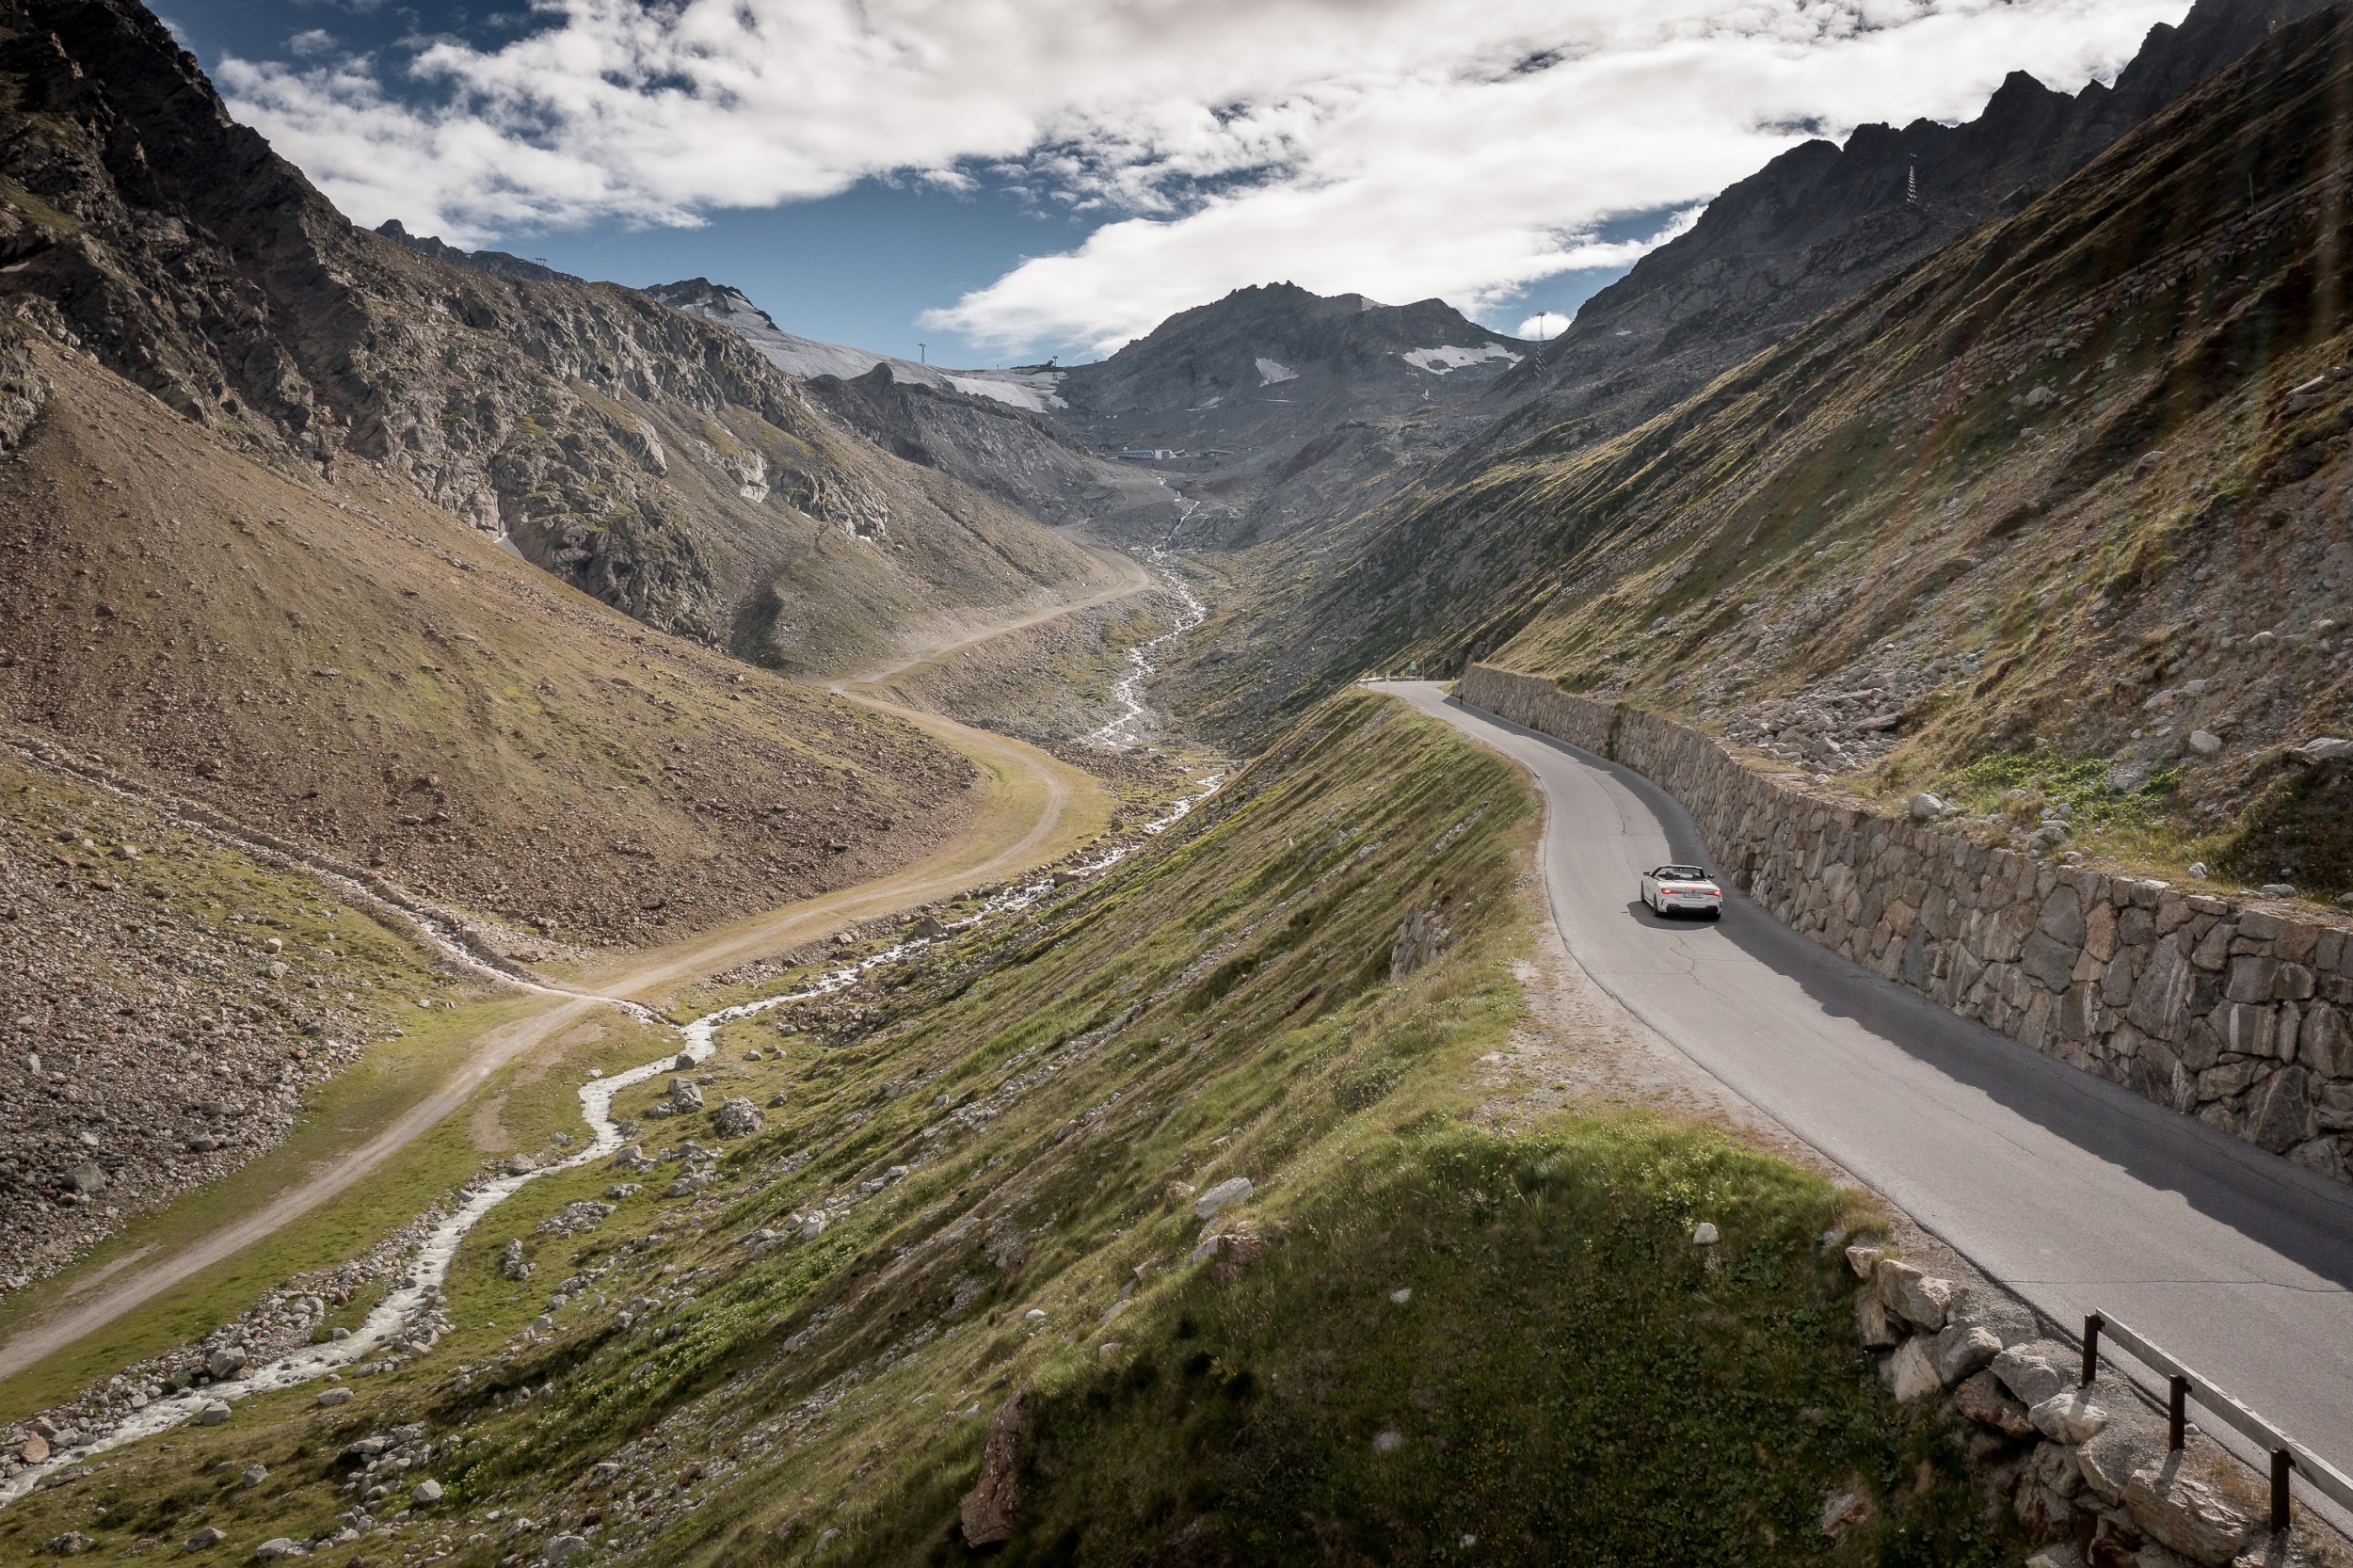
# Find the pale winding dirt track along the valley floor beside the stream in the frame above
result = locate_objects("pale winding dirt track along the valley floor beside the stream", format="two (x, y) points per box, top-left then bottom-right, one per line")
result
(0, 706), (1106, 1380)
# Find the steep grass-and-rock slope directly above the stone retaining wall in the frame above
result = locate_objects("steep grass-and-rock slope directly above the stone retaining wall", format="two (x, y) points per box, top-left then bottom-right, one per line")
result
(1224, 8), (2353, 897)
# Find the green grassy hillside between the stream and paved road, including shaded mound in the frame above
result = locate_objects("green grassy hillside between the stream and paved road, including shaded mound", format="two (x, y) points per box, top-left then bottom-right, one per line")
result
(0, 695), (2024, 1563)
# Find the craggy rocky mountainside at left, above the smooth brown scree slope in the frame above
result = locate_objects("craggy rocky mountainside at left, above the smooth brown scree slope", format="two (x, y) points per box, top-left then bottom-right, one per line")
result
(0, 0), (1111, 671)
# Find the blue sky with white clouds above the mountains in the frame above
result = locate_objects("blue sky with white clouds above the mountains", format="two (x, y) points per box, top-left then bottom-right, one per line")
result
(163, 0), (2188, 365)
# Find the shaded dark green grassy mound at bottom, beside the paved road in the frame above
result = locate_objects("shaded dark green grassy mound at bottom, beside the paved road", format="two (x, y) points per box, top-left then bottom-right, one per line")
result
(918, 1116), (2008, 1563)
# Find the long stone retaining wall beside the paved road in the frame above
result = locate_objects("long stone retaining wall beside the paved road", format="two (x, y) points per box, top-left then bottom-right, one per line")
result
(1457, 664), (2353, 1182)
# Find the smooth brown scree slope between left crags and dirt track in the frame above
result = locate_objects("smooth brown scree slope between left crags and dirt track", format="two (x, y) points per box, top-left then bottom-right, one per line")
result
(0, 348), (974, 942)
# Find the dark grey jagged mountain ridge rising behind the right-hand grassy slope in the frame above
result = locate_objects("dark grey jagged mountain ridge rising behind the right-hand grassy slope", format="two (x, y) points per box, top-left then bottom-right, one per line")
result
(1148, 0), (2320, 753)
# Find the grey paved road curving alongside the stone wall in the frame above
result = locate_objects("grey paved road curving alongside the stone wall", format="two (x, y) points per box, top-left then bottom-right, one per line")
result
(1374, 680), (2353, 1499)
